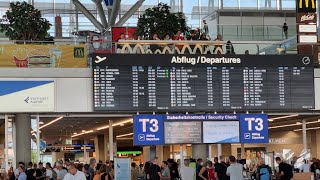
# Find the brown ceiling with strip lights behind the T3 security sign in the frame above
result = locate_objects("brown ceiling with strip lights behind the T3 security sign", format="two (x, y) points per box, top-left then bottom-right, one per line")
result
(33, 114), (320, 141)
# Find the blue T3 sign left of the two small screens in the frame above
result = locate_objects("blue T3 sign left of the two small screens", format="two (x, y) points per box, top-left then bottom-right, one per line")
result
(133, 115), (163, 146)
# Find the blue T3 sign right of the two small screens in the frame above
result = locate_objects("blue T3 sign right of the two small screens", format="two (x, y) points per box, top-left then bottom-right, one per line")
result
(240, 114), (269, 144)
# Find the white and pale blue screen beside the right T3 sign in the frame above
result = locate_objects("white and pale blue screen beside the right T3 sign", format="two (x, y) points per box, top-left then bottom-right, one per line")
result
(203, 121), (240, 144)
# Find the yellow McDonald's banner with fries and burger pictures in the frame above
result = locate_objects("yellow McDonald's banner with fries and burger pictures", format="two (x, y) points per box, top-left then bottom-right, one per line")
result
(0, 44), (87, 68)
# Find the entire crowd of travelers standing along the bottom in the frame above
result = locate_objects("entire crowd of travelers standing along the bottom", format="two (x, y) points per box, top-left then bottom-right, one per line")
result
(10, 154), (320, 180)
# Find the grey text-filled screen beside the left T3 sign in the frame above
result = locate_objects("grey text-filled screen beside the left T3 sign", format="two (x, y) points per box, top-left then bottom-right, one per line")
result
(164, 121), (202, 144)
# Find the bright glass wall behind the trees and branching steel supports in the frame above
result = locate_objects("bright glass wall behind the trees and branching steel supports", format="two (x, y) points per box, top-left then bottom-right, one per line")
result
(0, 0), (295, 37)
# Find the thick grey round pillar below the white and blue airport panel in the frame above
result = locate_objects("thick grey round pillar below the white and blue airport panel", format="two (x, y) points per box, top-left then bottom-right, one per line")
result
(15, 114), (31, 163)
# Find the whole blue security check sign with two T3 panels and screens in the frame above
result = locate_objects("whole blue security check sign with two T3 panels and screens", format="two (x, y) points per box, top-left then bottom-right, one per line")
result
(134, 114), (269, 146)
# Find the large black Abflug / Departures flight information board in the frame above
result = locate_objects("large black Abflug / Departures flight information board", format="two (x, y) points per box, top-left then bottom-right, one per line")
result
(92, 54), (314, 112)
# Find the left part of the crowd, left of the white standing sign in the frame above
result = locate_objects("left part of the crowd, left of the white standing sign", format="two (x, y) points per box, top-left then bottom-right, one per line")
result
(9, 158), (114, 180)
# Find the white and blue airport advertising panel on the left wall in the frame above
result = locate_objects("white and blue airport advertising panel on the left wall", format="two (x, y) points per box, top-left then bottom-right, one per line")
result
(0, 81), (55, 112)
